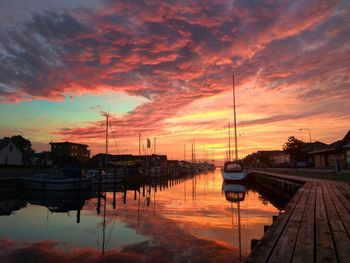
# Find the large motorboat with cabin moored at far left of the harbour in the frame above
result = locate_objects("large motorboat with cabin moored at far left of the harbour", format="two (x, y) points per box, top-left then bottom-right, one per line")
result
(21, 168), (91, 191)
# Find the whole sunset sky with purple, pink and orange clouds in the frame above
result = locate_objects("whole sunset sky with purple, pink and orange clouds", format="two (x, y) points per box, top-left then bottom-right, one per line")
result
(0, 0), (350, 161)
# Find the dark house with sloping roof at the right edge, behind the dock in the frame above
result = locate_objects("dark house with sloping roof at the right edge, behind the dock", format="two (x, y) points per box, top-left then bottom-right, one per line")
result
(309, 130), (350, 169)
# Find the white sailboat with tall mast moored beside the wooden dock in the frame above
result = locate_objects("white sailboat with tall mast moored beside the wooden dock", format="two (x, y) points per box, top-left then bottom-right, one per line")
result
(221, 76), (247, 181)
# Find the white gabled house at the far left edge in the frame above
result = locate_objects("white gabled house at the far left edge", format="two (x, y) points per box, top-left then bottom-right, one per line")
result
(0, 139), (23, 165)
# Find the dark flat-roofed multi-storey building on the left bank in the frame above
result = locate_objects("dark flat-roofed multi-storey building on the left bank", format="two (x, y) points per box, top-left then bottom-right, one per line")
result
(50, 141), (90, 163)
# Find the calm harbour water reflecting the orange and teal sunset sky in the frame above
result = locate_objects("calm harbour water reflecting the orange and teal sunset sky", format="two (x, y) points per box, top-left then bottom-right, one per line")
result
(0, 169), (279, 263)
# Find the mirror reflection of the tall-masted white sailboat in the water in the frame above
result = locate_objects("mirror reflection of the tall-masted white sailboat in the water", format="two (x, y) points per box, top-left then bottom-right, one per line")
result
(222, 181), (247, 262)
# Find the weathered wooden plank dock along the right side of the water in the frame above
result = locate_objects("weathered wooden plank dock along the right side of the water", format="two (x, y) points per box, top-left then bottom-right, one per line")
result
(246, 172), (350, 262)
